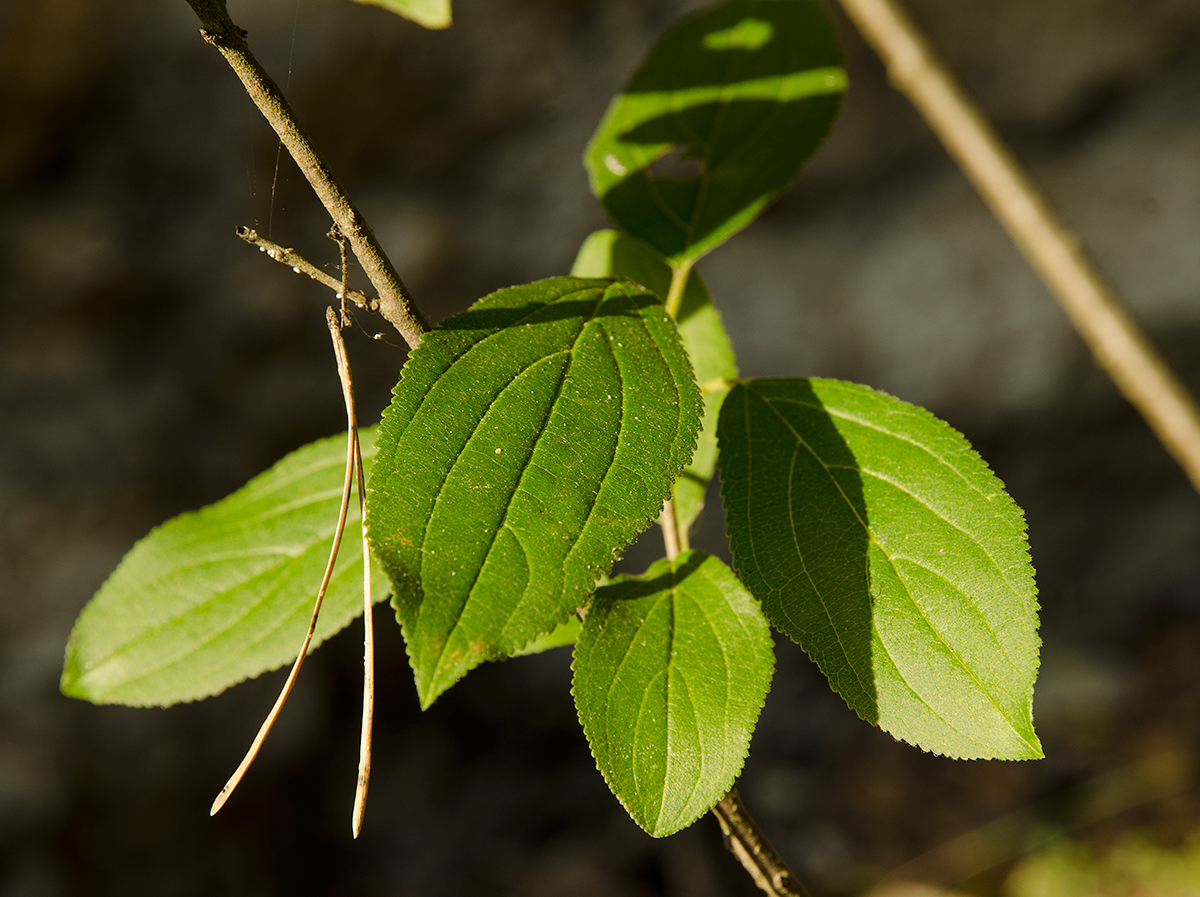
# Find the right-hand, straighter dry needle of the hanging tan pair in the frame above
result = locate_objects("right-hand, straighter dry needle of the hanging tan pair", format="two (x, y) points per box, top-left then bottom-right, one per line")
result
(325, 309), (374, 838)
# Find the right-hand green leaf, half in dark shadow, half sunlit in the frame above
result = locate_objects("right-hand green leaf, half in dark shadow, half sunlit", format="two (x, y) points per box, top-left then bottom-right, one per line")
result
(718, 379), (1042, 759)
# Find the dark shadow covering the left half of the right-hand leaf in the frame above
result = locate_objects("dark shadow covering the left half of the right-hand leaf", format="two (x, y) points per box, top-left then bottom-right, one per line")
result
(720, 380), (880, 724)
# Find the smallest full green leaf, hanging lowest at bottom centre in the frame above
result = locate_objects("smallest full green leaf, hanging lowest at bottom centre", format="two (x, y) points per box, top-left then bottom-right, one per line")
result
(572, 552), (774, 837)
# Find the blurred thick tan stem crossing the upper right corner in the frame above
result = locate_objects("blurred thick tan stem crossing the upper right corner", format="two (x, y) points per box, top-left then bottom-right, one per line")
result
(841, 0), (1200, 490)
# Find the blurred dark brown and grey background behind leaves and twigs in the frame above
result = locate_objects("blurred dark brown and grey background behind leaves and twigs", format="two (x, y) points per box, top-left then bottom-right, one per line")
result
(7, 0), (1200, 897)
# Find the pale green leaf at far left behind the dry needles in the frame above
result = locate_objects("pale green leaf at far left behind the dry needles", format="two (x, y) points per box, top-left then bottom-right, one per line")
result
(61, 427), (388, 706)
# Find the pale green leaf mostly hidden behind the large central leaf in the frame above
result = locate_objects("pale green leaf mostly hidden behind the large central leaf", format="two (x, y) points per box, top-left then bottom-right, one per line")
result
(571, 230), (738, 532)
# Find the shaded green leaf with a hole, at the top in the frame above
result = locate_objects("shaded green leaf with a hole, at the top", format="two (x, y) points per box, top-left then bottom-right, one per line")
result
(583, 0), (846, 263)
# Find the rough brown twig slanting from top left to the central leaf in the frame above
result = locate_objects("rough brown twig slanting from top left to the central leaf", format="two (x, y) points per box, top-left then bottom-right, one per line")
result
(187, 0), (428, 349)
